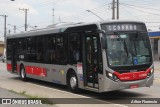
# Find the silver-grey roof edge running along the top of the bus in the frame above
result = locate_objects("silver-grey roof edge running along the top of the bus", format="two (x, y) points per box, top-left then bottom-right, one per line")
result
(7, 20), (144, 39)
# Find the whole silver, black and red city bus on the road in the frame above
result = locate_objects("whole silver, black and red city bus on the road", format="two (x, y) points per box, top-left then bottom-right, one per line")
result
(6, 21), (154, 93)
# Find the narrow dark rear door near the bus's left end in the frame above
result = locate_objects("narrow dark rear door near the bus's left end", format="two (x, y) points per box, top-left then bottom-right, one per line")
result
(11, 41), (17, 72)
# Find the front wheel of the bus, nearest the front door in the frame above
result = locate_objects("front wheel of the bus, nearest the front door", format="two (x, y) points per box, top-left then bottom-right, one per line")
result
(67, 72), (79, 93)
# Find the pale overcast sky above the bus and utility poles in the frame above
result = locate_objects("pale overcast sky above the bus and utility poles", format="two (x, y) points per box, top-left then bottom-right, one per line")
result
(0, 0), (160, 40)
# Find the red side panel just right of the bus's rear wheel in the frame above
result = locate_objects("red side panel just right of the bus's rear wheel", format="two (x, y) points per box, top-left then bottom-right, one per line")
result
(25, 66), (46, 77)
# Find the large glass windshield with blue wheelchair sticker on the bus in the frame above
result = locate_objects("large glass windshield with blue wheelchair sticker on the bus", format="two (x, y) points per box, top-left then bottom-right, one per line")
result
(106, 32), (152, 66)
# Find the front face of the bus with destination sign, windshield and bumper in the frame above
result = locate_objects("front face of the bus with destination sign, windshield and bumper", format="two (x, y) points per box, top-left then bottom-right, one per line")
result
(101, 22), (154, 91)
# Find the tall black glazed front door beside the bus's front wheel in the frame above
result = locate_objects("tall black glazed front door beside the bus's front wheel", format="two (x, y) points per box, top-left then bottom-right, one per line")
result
(83, 35), (98, 89)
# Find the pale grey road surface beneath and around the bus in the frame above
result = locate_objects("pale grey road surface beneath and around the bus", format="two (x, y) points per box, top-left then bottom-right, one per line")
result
(0, 62), (160, 107)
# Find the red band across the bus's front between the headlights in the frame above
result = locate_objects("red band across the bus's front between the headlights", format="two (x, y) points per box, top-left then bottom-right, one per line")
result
(114, 68), (151, 81)
